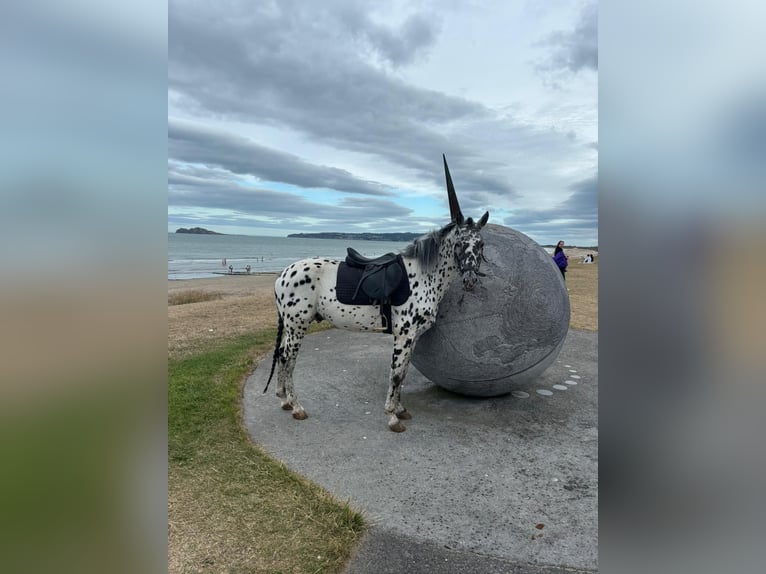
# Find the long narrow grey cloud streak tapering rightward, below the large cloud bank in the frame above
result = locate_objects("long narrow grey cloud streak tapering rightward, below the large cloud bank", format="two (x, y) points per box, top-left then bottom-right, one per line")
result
(168, 118), (392, 196)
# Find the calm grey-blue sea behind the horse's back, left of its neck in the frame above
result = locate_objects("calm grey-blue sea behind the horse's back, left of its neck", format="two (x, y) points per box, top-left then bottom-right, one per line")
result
(168, 233), (410, 280)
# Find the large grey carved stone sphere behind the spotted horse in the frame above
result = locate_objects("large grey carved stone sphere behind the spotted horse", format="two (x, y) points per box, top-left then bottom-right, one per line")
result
(412, 224), (569, 397)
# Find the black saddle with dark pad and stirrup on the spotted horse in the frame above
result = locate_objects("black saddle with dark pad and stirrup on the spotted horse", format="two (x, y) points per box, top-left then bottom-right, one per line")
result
(335, 247), (412, 333)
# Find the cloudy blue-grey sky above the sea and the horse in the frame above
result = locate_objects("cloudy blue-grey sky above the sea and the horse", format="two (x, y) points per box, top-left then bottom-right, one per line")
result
(168, 0), (598, 246)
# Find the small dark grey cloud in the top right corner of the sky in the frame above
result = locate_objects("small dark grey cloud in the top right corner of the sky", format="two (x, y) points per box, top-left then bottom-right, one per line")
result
(540, 2), (598, 73)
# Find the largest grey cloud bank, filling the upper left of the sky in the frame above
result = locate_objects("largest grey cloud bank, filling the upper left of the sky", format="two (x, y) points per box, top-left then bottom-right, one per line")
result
(168, 2), (500, 182)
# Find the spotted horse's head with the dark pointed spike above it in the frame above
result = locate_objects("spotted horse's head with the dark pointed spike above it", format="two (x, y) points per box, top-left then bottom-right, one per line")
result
(442, 155), (489, 291)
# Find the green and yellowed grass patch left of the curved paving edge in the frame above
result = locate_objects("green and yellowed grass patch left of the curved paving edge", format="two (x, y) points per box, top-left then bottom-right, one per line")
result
(168, 329), (365, 573)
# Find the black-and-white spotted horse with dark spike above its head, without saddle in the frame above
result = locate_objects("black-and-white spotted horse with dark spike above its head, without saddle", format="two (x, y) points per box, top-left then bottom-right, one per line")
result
(263, 158), (489, 432)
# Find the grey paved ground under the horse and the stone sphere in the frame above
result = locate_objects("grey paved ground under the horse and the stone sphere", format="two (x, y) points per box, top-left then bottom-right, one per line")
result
(244, 330), (598, 574)
